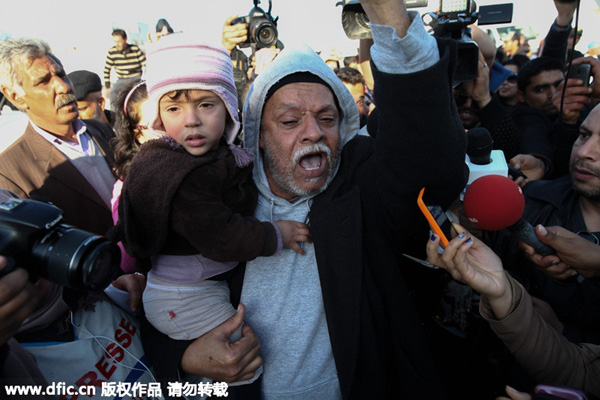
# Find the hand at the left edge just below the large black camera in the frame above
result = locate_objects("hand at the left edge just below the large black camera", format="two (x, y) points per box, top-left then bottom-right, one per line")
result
(0, 256), (39, 345)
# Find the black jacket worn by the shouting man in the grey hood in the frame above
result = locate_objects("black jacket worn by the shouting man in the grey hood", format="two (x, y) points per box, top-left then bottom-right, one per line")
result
(146, 41), (467, 400)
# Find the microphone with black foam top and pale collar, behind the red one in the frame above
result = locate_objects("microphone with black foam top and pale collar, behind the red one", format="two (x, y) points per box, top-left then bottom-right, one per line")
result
(460, 127), (508, 200)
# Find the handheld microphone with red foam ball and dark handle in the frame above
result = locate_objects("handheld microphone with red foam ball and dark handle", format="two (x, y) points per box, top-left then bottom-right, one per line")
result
(463, 175), (556, 256)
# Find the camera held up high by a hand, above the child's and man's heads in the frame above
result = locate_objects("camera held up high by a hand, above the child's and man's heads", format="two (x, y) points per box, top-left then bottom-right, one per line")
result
(231, 0), (279, 50)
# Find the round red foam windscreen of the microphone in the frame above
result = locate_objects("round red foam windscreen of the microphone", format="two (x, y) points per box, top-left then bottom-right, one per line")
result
(463, 175), (525, 231)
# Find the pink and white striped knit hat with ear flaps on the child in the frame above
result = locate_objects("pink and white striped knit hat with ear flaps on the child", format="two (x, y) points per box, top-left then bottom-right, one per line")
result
(146, 33), (240, 144)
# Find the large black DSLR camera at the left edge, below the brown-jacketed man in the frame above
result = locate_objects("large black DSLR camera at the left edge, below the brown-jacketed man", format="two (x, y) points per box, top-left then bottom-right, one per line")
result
(0, 199), (121, 290)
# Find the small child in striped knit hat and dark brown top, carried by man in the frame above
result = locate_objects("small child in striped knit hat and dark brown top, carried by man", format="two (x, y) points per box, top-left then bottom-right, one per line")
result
(119, 34), (310, 379)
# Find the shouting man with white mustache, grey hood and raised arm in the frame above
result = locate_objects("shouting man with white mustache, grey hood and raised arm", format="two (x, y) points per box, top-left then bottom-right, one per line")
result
(146, 0), (466, 399)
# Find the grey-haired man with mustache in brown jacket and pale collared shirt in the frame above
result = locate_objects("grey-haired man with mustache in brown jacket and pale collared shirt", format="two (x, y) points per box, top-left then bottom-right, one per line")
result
(0, 39), (115, 235)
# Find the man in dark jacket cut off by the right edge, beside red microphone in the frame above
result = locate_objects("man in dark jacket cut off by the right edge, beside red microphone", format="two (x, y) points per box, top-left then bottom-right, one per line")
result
(495, 106), (600, 344)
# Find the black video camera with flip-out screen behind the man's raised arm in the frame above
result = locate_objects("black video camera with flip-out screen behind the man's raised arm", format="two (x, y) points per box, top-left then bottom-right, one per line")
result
(342, 0), (512, 83)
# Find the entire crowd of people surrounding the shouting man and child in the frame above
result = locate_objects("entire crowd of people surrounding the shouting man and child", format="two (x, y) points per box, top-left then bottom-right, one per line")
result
(0, 0), (600, 400)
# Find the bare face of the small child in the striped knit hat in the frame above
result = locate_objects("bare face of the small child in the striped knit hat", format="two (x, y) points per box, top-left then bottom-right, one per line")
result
(158, 90), (227, 156)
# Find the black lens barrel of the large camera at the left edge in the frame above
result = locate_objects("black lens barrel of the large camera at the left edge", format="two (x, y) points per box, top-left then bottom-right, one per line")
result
(31, 225), (121, 290)
